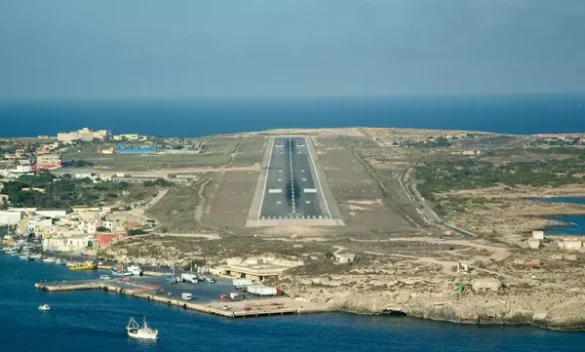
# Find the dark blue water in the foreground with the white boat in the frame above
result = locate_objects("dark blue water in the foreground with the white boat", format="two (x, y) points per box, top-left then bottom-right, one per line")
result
(0, 255), (585, 352)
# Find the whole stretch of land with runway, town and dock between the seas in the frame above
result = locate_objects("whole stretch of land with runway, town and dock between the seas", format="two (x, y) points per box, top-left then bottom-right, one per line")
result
(0, 128), (585, 330)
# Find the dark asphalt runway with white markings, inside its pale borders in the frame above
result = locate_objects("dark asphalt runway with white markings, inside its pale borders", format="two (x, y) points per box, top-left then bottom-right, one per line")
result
(260, 137), (329, 220)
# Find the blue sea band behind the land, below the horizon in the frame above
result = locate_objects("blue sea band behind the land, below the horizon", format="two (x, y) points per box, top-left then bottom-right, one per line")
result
(0, 95), (585, 137)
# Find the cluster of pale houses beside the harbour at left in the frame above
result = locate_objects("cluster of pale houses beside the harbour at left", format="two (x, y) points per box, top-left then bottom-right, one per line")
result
(0, 207), (151, 254)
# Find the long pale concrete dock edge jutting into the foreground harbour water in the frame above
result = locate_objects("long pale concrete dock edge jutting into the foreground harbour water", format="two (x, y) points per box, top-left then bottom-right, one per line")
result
(35, 280), (326, 318)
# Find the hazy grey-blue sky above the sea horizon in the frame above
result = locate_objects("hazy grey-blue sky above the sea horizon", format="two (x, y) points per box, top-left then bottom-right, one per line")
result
(0, 0), (585, 99)
